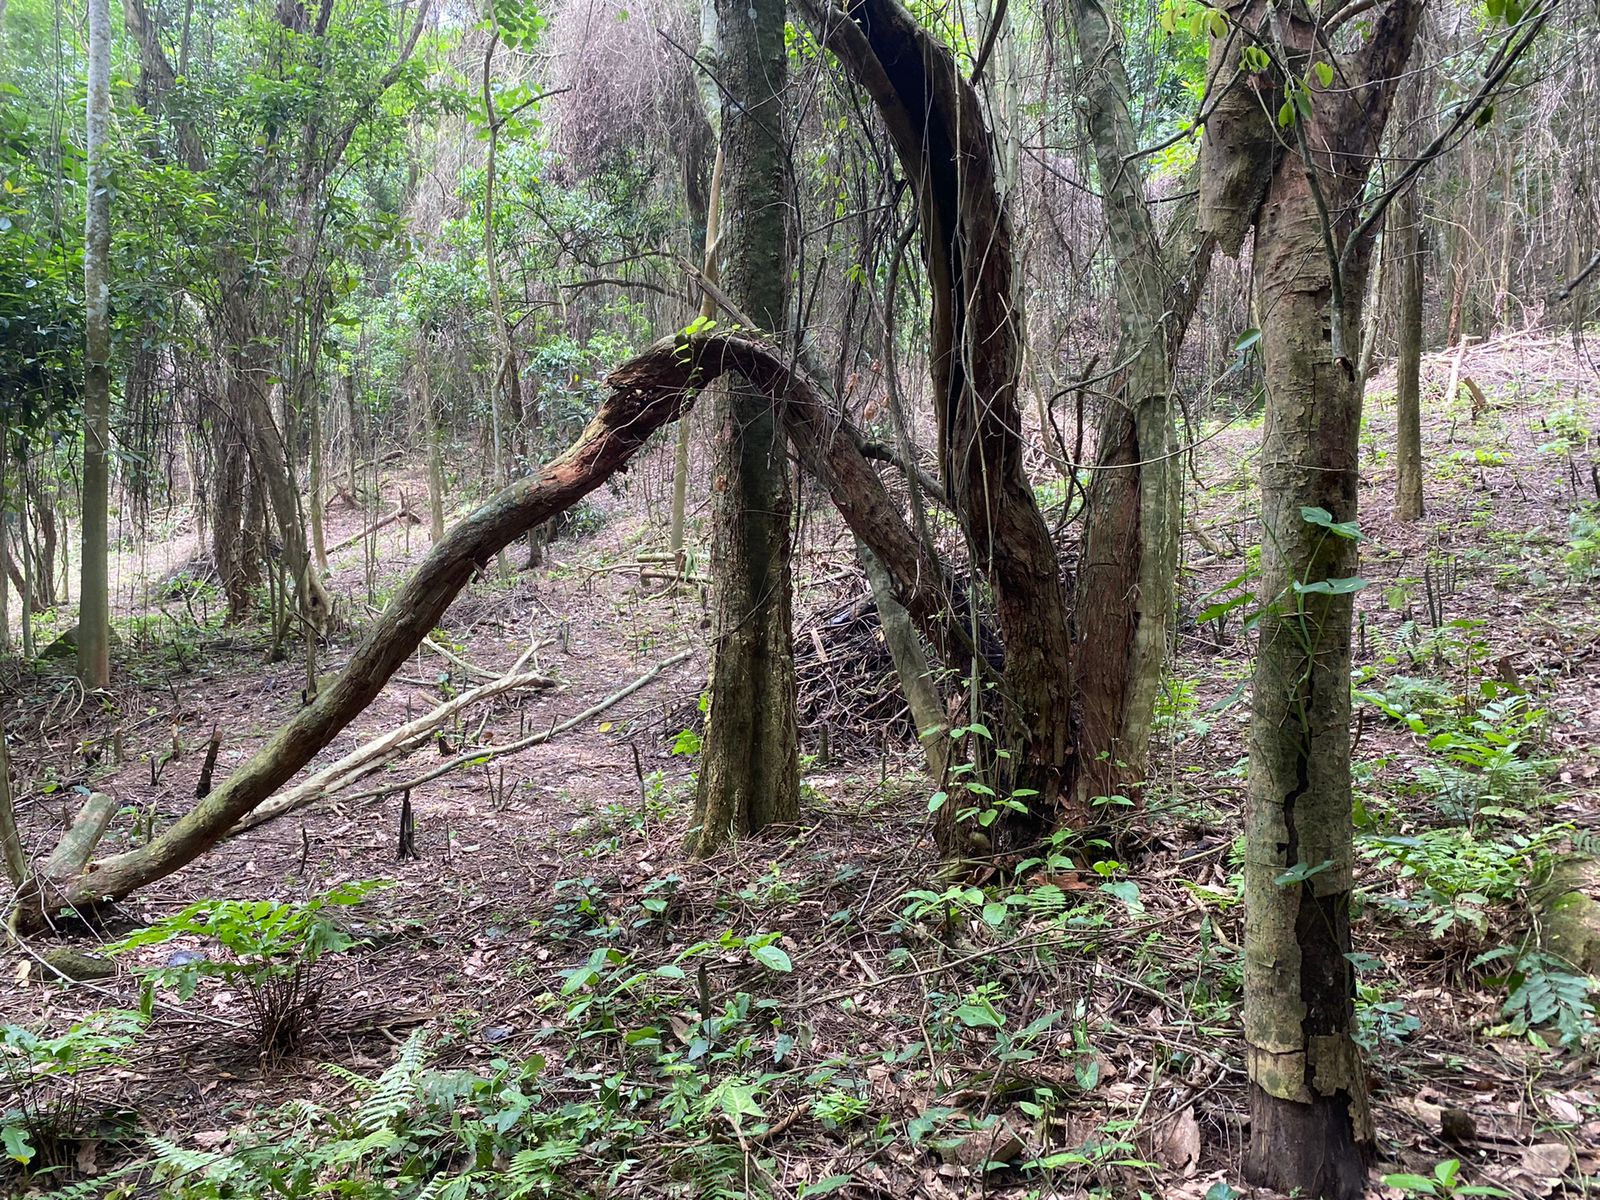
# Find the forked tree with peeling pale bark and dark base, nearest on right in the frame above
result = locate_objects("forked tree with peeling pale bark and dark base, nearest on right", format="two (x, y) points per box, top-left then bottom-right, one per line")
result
(1202, 0), (1421, 1200)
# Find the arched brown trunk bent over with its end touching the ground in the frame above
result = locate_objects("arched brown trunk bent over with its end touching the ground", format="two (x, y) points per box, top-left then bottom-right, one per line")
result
(16, 333), (939, 930)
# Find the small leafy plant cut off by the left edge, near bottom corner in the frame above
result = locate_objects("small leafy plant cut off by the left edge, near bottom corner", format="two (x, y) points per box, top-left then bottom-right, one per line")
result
(0, 1008), (146, 1171)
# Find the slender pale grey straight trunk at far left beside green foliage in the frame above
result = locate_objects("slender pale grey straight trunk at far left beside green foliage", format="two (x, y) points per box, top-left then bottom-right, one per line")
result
(78, 0), (110, 688)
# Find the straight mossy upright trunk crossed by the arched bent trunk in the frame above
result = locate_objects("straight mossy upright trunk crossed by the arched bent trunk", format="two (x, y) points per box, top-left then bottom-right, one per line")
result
(693, 0), (800, 853)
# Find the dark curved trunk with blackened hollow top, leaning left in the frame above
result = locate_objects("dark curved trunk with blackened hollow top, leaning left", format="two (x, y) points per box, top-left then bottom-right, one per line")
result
(803, 0), (1082, 854)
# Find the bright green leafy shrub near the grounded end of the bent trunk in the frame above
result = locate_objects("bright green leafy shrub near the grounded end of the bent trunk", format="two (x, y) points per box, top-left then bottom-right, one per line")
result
(110, 880), (387, 1054)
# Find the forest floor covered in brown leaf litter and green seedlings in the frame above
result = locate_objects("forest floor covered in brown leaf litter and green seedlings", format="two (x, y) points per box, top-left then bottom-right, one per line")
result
(0, 336), (1600, 1200)
